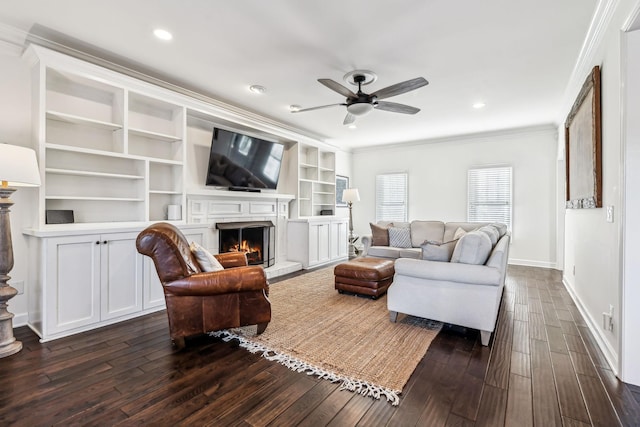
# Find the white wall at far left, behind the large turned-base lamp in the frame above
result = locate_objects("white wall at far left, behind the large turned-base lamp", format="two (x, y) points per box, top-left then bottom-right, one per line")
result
(0, 50), (37, 325)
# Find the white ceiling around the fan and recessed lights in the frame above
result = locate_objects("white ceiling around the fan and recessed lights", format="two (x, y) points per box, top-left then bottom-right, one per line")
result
(0, 0), (598, 148)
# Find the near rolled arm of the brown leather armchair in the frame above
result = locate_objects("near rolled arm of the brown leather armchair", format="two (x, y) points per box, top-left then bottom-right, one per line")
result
(164, 266), (268, 296)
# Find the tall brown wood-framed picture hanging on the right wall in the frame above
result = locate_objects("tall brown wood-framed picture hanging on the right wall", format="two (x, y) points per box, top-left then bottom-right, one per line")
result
(564, 66), (602, 209)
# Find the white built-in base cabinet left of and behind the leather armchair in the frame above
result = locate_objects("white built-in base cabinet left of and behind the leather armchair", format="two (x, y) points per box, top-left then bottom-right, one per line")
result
(28, 228), (207, 341)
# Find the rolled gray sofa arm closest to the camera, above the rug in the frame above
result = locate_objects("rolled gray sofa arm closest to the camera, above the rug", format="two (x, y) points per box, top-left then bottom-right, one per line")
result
(395, 258), (504, 286)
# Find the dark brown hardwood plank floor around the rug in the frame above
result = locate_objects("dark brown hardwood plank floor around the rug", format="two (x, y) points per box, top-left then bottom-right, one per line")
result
(0, 267), (640, 427)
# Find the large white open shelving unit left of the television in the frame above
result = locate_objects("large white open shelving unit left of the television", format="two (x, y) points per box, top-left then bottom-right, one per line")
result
(29, 47), (186, 227)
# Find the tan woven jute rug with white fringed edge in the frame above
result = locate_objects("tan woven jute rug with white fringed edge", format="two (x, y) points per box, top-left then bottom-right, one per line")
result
(211, 267), (442, 405)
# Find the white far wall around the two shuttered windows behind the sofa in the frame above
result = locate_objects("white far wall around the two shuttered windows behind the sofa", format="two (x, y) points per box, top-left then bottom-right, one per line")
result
(352, 125), (557, 268)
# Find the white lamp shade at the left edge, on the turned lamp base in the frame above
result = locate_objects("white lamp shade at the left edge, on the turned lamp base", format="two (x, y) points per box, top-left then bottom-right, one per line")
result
(0, 144), (40, 187)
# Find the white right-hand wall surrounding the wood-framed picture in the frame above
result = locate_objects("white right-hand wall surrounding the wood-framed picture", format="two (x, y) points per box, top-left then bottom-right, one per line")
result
(561, 0), (640, 383)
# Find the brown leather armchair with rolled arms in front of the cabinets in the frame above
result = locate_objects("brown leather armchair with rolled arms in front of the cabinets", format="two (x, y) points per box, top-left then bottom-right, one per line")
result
(136, 222), (271, 349)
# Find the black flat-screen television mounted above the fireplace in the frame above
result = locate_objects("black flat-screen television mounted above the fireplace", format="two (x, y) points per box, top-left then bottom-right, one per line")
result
(206, 128), (284, 191)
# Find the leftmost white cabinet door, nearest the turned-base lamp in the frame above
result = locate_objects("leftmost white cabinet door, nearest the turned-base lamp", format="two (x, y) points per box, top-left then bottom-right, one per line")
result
(43, 235), (101, 336)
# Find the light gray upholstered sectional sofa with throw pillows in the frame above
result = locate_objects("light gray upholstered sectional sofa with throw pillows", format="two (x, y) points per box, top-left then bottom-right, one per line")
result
(362, 221), (510, 345)
